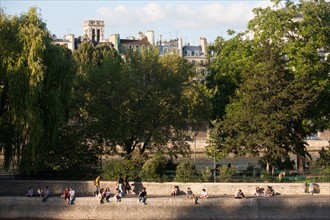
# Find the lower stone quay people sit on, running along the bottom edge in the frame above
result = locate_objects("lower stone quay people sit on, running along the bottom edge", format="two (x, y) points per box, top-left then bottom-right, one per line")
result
(0, 195), (330, 220)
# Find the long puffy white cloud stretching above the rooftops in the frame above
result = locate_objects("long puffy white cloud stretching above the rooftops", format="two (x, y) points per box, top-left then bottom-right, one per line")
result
(97, 1), (270, 28)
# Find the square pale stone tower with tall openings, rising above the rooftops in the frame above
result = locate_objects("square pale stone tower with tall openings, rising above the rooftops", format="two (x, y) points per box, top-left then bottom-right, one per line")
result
(83, 20), (104, 42)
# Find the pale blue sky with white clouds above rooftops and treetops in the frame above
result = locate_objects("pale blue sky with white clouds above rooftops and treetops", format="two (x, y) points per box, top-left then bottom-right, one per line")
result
(0, 0), (278, 46)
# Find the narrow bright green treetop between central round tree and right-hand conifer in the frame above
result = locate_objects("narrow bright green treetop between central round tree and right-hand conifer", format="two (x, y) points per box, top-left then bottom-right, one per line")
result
(206, 36), (250, 120)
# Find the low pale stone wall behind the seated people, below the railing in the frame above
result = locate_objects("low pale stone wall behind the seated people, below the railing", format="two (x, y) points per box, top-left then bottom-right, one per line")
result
(0, 180), (330, 196)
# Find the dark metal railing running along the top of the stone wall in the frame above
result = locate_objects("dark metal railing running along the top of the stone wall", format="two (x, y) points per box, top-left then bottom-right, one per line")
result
(0, 167), (330, 182)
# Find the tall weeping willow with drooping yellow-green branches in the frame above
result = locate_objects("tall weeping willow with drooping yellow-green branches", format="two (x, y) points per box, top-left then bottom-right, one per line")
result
(0, 8), (75, 175)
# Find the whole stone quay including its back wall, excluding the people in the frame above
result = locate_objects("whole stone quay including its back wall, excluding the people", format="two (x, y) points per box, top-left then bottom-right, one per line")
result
(0, 180), (330, 220)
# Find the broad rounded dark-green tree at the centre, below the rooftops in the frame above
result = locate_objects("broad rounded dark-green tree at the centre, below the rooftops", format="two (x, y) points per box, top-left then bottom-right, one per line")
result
(86, 48), (207, 158)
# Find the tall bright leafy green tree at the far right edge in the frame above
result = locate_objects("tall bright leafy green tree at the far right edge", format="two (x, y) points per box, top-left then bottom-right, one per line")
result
(249, 0), (330, 171)
